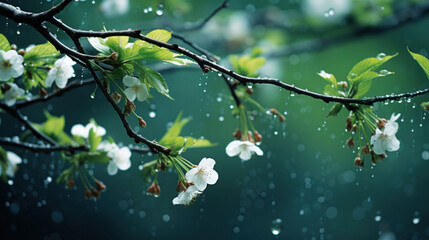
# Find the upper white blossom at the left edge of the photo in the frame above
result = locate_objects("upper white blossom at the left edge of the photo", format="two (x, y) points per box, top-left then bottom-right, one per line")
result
(0, 50), (24, 82)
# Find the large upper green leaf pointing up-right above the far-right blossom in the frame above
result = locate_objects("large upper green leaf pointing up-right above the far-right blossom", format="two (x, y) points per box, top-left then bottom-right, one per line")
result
(347, 53), (398, 83)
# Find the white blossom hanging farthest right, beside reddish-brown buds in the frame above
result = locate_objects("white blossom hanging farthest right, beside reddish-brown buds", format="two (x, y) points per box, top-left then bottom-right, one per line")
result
(371, 113), (401, 155)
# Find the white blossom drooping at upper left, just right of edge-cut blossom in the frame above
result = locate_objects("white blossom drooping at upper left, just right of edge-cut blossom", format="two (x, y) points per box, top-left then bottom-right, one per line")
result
(45, 56), (76, 88)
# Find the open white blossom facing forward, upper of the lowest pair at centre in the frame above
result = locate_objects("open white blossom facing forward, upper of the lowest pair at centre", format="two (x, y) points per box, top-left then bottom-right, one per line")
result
(185, 158), (219, 191)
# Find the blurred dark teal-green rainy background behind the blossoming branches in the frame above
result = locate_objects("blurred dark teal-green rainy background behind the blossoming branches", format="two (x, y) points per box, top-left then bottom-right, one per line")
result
(0, 0), (429, 240)
